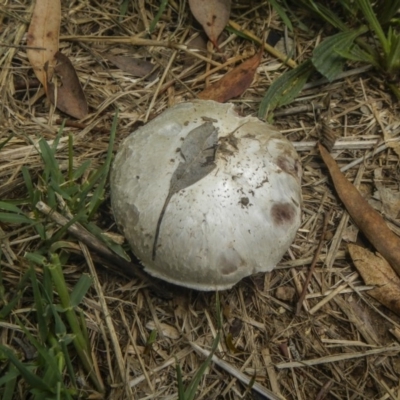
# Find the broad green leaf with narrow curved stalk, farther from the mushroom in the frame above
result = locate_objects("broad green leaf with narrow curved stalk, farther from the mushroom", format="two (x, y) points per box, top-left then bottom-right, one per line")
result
(311, 26), (368, 82)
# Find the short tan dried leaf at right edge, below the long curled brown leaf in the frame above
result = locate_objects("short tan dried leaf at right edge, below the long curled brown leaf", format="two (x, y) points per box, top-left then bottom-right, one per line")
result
(348, 244), (400, 315)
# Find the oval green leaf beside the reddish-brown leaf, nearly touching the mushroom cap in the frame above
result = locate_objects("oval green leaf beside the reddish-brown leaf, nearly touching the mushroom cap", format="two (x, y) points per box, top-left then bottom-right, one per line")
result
(258, 60), (314, 119)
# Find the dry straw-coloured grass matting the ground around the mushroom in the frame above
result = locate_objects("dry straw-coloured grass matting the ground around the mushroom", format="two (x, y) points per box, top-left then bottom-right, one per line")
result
(0, 0), (400, 400)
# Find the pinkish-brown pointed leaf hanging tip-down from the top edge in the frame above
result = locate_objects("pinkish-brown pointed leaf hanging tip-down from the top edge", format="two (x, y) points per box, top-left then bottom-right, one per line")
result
(189, 0), (231, 48)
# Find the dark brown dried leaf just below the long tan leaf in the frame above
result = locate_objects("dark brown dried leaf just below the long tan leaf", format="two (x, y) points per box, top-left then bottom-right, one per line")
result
(48, 52), (88, 119)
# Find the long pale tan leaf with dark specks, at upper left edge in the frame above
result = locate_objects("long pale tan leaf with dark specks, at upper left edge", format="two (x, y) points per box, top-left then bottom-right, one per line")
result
(26, 0), (61, 92)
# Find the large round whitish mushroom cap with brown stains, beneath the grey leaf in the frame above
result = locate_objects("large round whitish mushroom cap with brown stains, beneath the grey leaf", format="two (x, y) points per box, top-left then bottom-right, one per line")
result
(110, 100), (302, 290)
